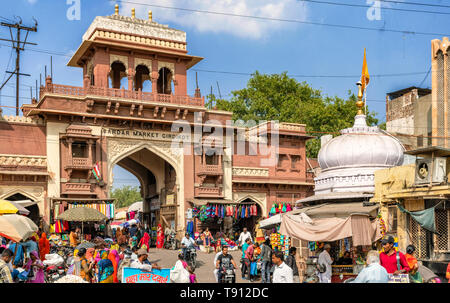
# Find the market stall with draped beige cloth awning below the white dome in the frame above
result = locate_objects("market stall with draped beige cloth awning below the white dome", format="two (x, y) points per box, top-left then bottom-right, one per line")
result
(260, 202), (383, 282)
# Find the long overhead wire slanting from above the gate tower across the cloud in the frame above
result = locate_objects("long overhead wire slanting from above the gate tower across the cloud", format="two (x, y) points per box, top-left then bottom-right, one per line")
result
(109, 0), (450, 36)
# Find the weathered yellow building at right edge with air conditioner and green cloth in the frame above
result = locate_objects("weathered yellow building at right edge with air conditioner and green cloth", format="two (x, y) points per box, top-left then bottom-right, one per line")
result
(370, 146), (450, 273)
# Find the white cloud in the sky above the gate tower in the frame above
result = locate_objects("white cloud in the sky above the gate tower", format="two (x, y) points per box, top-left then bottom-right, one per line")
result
(120, 0), (307, 39)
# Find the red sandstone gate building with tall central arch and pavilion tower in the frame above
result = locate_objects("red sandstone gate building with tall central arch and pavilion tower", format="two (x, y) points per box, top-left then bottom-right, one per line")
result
(0, 7), (313, 233)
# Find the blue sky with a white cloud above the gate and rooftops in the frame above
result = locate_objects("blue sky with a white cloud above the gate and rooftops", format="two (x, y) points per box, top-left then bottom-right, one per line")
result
(0, 0), (450, 190)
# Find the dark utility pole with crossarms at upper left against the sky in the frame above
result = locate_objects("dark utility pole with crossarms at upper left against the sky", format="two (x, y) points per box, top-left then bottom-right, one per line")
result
(0, 17), (37, 116)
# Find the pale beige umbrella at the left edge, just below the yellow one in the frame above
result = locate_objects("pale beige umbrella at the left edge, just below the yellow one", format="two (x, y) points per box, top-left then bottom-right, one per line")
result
(0, 214), (39, 242)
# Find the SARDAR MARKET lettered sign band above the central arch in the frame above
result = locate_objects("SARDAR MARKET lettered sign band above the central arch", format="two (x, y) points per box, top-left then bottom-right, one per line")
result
(102, 128), (189, 141)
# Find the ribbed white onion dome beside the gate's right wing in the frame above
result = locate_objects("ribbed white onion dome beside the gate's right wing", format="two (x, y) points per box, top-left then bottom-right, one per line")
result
(314, 115), (405, 194)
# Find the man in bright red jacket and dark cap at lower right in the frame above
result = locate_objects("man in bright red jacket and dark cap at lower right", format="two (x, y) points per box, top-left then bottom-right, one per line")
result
(380, 236), (409, 275)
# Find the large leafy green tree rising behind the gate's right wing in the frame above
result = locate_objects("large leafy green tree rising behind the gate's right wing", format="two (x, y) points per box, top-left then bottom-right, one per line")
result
(207, 71), (378, 158)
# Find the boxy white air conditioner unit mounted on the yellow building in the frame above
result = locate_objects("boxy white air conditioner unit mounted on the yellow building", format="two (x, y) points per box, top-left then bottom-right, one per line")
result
(415, 157), (447, 184)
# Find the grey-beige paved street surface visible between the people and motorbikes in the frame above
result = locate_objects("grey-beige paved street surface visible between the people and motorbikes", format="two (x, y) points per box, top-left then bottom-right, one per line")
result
(149, 248), (253, 283)
